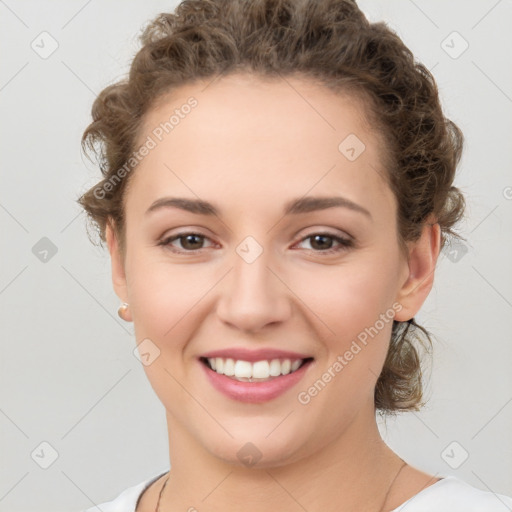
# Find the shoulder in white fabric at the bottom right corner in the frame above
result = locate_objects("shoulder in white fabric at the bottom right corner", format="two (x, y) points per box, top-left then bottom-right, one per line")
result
(392, 476), (512, 512)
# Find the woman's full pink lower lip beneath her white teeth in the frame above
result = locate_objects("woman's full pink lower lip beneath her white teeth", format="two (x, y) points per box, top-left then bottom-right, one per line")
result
(199, 361), (312, 403)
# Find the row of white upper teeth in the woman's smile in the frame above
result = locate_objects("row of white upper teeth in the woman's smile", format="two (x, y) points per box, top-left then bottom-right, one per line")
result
(208, 357), (303, 380)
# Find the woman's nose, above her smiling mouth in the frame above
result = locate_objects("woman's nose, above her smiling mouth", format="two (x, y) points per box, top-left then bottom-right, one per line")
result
(217, 246), (292, 332)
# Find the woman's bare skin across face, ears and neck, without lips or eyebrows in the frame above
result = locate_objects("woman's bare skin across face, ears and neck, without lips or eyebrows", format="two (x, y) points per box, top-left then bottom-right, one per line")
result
(106, 74), (440, 512)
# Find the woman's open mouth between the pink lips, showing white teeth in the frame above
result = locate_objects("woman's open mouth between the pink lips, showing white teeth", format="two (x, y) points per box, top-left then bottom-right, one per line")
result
(199, 357), (313, 382)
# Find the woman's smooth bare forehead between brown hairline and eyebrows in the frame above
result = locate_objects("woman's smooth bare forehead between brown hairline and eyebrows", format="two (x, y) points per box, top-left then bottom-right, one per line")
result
(130, 74), (392, 214)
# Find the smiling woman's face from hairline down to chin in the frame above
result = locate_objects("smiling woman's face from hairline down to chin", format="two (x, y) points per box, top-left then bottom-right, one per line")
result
(109, 75), (436, 466)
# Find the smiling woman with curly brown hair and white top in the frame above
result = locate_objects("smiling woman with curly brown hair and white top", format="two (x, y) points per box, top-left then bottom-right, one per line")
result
(79, 0), (512, 512)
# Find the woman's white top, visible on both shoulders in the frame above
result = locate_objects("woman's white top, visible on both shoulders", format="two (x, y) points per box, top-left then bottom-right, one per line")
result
(83, 471), (512, 512)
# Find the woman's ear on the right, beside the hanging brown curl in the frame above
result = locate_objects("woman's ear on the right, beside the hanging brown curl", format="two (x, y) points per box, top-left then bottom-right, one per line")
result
(395, 220), (441, 322)
